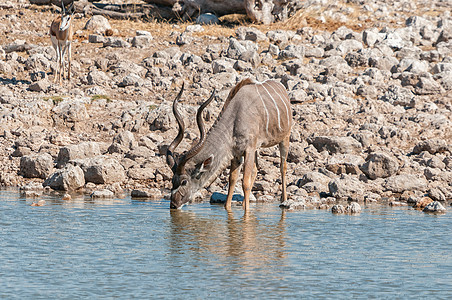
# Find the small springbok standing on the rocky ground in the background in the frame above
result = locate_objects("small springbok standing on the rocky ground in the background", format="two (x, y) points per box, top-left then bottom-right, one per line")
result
(50, 0), (74, 85)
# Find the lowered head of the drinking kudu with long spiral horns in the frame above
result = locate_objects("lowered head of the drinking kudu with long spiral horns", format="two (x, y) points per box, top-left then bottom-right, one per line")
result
(166, 84), (215, 208)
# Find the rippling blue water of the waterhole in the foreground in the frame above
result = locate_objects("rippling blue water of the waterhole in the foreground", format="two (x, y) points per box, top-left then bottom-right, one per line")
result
(0, 191), (452, 299)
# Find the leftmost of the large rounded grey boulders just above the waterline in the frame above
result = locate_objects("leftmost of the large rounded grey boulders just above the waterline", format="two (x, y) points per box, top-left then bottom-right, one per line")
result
(19, 153), (53, 179)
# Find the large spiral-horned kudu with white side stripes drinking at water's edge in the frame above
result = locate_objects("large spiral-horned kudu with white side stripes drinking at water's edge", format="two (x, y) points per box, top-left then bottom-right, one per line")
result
(166, 79), (292, 211)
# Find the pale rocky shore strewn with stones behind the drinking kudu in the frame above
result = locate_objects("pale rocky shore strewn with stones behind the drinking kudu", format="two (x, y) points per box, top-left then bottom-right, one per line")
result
(0, 0), (452, 212)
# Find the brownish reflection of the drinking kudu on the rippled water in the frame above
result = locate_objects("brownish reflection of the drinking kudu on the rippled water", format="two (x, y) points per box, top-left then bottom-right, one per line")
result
(168, 210), (287, 272)
